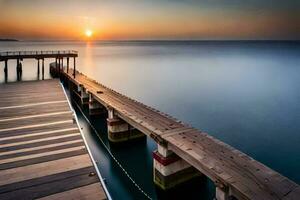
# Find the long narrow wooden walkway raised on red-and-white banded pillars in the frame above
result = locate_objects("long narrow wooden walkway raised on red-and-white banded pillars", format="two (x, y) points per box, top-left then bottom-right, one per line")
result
(63, 70), (300, 200)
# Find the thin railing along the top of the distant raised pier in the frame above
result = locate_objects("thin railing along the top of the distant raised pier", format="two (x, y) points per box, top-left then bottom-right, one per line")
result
(0, 50), (78, 56)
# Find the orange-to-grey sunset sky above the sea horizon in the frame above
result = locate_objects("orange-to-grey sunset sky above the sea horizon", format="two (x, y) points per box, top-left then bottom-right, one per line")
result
(0, 0), (300, 40)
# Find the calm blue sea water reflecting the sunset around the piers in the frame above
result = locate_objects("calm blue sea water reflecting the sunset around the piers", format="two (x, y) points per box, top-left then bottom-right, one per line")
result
(0, 42), (300, 199)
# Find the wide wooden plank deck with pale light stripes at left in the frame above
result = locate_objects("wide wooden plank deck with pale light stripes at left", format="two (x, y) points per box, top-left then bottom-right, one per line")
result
(0, 80), (107, 200)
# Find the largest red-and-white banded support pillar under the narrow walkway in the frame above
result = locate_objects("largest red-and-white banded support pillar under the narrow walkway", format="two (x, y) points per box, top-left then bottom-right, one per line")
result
(153, 144), (202, 190)
